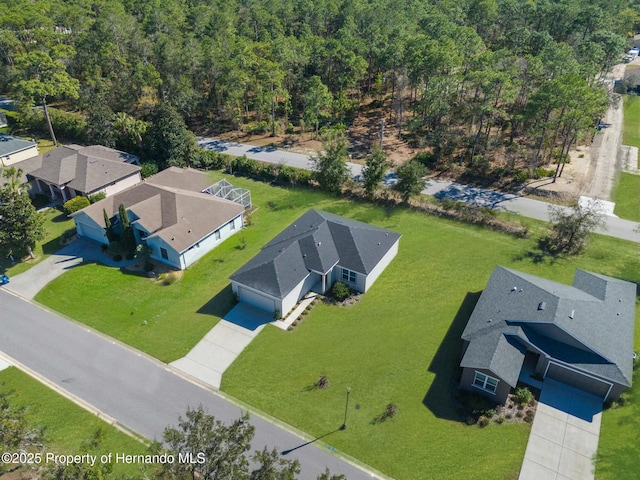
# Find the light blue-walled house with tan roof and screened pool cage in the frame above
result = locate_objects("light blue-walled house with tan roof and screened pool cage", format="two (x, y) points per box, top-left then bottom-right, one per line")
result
(71, 167), (245, 269)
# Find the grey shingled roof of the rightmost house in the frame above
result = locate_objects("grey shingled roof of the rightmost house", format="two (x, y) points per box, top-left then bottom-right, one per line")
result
(461, 267), (636, 386)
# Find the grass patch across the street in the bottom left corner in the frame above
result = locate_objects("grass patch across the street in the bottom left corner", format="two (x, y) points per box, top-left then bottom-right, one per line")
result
(0, 367), (147, 476)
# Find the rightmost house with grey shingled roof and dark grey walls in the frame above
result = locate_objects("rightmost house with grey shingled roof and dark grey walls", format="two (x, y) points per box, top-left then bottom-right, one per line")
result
(460, 267), (636, 403)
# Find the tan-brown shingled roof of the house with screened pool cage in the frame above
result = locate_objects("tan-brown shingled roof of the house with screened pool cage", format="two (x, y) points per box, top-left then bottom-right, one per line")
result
(72, 167), (244, 253)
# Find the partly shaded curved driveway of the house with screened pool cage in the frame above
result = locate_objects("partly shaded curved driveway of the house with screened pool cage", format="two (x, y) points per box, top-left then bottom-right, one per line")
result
(3, 238), (136, 300)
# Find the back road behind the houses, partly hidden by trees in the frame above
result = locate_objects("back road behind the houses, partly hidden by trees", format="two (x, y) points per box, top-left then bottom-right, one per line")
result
(198, 137), (640, 243)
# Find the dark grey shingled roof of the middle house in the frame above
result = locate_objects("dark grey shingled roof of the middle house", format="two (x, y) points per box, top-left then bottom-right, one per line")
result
(229, 210), (400, 298)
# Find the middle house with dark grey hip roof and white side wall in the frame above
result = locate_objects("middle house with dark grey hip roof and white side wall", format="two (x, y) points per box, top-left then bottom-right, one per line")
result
(229, 210), (400, 315)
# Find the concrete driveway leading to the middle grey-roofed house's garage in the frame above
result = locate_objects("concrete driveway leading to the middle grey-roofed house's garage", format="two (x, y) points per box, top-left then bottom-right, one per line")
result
(171, 303), (273, 388)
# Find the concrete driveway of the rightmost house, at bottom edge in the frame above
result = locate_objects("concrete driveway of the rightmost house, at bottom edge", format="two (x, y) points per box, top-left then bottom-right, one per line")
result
(519, 379), (602, 480)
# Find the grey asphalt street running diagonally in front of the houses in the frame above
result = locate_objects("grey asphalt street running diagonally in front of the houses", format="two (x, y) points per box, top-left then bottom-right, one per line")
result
(0, 288), (380, 480)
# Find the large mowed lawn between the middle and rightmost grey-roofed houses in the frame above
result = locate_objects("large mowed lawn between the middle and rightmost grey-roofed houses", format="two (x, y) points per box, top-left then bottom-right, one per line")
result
(222, 206), (640, 479)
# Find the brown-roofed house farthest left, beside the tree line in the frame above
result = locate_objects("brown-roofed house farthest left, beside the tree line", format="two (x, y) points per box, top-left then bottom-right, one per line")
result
(15, 145), (142, 202)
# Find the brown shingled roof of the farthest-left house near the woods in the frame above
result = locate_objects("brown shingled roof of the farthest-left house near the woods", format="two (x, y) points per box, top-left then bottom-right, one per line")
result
(28, 145), (140, 193)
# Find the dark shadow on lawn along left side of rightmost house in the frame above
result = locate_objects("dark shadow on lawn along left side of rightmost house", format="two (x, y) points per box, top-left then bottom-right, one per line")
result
(422, 292), (481, 421)
